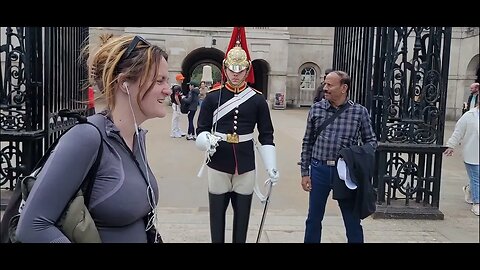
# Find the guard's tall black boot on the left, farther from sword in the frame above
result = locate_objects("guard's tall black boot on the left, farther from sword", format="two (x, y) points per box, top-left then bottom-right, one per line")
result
(208, 192), (231, 243)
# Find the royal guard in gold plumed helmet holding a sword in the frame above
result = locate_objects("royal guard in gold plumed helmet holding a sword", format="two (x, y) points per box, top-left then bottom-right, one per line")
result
(196, 27), (279, 243)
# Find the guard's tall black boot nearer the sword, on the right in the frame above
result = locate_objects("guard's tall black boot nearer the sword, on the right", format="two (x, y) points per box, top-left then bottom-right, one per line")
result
(232, 192), (253, 243)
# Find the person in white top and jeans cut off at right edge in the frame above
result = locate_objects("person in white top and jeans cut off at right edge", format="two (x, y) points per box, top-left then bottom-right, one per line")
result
(444, 99), (479, 216)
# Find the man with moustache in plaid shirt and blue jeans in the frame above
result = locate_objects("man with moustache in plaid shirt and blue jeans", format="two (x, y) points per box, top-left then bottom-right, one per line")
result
(301, 70), (377, 243)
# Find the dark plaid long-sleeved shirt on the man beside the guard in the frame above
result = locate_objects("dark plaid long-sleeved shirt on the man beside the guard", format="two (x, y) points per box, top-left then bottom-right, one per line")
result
(301, 99), (377, 177)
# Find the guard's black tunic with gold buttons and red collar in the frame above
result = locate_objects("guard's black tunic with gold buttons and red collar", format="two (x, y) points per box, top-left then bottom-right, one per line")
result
(197, 83), (275, 174)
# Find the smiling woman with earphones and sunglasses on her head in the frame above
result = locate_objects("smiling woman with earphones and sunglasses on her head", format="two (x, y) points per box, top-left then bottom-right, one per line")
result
(17, 35), (171, 243)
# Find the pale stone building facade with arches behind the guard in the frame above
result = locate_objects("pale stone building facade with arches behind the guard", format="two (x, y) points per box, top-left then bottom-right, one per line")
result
(0, 27), (480, 120)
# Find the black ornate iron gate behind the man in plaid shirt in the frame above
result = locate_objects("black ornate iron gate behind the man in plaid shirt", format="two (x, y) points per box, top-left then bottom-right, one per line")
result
(333, 27), (451, 219)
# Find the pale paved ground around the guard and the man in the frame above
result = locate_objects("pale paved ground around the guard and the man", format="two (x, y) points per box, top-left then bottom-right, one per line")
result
(1, 100), (480, 243)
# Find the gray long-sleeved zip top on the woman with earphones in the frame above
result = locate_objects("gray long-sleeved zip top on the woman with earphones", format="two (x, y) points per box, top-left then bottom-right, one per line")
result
(17, 114), (158, 243)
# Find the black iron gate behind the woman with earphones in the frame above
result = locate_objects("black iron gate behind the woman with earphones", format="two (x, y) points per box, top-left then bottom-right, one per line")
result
(0, 27), (89, 195)
